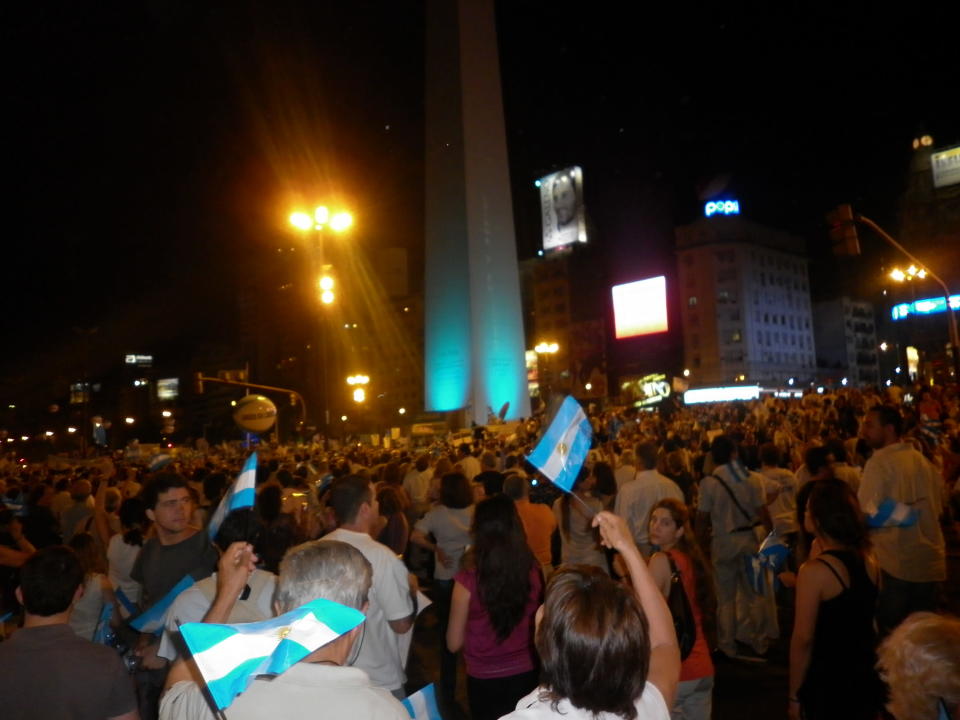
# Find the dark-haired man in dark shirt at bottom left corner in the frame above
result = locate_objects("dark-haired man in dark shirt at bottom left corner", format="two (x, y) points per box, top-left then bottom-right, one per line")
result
(0, 545), (140, 720)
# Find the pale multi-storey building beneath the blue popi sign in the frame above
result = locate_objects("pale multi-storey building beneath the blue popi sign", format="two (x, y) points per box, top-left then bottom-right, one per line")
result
(676, 214), (816, 386)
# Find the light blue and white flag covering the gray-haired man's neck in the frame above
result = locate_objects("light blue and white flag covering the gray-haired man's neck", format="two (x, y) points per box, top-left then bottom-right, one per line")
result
(180, 598), (364, 710)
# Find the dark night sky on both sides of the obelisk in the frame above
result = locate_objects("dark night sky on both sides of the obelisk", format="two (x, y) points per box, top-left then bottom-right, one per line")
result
(0, 0), (960, 376)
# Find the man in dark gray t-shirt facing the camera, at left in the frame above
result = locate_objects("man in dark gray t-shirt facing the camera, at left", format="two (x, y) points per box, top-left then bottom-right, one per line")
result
(130, 473), (218, 720)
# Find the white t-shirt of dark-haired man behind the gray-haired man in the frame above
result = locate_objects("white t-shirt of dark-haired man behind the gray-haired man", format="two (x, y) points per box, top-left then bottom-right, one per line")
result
(322, 528), (413, 690)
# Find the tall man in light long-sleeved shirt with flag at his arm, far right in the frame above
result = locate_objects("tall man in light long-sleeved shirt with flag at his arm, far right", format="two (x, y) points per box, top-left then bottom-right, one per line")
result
(858, 405), (947, 634)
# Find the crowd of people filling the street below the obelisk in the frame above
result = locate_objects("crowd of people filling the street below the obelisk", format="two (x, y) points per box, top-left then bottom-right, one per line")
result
(0, 380), (960, 720)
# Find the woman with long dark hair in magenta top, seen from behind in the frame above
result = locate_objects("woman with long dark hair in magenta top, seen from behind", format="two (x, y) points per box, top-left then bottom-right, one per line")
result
(447, 495), (543, 720)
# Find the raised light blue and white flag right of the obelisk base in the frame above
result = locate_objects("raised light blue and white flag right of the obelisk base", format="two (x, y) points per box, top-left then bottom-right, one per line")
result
(527, 395), (593, 492)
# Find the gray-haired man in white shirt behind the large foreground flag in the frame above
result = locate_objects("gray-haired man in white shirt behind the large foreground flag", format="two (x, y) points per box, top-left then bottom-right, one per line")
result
(160, 540), (409, 720)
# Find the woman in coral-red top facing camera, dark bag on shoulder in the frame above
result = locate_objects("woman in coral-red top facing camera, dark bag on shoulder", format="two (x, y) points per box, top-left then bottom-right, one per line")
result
(650, 498), (716, 720)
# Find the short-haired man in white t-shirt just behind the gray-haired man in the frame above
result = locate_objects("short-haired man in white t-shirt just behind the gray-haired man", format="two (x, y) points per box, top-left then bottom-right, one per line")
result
(321, 475), (417, 698)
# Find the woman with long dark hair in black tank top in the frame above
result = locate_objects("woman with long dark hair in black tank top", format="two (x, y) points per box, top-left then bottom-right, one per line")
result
(788, 479), (883, 720)
